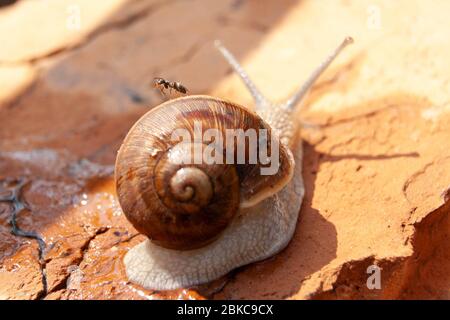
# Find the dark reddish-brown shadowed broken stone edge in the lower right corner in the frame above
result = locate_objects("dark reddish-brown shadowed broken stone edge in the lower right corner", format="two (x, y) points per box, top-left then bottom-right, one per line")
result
(305, 195), (450, 300)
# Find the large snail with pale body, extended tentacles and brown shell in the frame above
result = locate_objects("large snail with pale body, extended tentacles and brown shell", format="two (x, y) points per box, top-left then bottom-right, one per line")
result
(115, 37), (353, 290)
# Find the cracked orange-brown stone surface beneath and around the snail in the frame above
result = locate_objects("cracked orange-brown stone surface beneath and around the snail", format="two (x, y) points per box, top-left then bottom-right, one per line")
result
(0, 0), (450, 299)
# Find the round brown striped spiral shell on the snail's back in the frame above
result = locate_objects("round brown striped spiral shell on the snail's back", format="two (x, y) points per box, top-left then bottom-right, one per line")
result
(115, 96), (294, 250)
